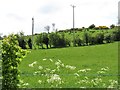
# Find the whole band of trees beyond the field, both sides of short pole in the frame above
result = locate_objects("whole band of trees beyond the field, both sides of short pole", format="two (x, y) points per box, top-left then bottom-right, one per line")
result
(1, 24), (120, 49)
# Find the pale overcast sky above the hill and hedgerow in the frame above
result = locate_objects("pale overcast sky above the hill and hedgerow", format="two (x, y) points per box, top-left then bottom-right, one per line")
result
(0, 0), (119, 35)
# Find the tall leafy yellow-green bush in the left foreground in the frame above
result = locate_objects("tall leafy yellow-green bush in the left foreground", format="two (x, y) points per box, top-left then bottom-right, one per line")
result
(2, 34), (27, 90)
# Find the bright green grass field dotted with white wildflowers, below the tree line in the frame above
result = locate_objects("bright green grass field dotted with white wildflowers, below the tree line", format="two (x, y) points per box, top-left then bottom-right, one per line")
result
(19, 42), (118, 88)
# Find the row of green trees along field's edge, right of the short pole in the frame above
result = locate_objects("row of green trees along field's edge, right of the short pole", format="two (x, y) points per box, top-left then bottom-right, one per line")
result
(35, 26), (120, 48)
